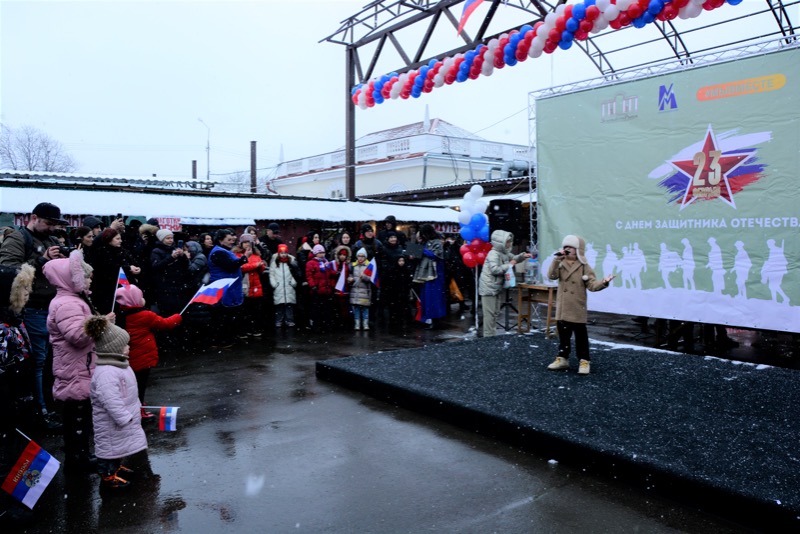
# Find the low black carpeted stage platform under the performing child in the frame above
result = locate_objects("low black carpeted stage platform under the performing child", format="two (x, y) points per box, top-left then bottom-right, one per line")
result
(317, 333), (800, 531)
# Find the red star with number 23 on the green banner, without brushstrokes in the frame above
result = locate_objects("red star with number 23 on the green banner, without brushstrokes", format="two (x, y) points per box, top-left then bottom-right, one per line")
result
(669, 124), (749, 209)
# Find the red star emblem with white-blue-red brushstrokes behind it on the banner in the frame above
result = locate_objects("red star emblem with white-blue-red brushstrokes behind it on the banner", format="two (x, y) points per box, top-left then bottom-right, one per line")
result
(650, 124), (772, 210)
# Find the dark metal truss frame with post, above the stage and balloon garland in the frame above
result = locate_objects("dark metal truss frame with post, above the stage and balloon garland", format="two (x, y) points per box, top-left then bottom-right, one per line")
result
(320, 0), (800, 200)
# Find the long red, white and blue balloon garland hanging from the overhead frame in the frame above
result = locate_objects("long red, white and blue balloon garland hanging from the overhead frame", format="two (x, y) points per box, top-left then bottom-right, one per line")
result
(350, 0), (742, 109)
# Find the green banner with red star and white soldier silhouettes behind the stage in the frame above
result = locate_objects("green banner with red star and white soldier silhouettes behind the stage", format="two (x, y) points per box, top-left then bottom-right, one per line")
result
(536, 48), (800, 332)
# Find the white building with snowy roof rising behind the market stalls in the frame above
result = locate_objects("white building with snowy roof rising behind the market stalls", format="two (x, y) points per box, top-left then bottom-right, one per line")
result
(268, 117), (531, 202)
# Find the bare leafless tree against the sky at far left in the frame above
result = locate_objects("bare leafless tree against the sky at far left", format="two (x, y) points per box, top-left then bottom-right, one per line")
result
(0, 125), (78, 172)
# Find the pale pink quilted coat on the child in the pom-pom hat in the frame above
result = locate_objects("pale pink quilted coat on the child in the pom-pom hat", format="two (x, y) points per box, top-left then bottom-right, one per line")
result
(91, 365), (147, 460)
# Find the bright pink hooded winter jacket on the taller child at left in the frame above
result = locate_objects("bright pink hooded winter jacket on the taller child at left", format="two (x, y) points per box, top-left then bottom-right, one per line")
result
(44, 250), (96, 401)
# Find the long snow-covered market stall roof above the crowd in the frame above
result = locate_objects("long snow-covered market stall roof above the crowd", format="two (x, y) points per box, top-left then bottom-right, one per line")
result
(0, 180), (458, 226)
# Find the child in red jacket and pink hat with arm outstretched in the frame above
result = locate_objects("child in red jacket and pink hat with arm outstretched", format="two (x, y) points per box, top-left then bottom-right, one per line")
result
(117, 284), (182, 420)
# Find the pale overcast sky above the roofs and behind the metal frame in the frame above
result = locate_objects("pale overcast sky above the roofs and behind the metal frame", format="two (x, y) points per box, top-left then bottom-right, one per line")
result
(0, 0), (788, 179)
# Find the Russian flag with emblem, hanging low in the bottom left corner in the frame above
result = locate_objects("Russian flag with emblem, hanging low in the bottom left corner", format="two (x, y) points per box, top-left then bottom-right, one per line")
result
(3, 431), (61, 509)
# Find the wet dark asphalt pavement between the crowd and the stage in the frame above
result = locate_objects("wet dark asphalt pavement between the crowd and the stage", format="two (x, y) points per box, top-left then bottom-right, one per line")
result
(15, 314), (760, 533)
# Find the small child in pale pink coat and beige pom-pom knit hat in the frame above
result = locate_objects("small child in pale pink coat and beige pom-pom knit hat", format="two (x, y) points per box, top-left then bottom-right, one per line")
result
(84, 316), (147, 490)
